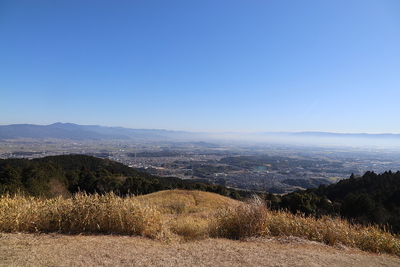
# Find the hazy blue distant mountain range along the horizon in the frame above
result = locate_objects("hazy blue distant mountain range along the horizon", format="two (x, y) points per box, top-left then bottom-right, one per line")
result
(0, 122), (400, 146)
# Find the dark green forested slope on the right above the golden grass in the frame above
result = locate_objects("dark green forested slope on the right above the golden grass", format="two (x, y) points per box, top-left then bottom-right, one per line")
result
(276, 171), (400, 233)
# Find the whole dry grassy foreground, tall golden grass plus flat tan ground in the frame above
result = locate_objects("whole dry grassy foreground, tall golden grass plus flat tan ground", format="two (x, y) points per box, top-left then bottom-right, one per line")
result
(0, 190), (400, 266)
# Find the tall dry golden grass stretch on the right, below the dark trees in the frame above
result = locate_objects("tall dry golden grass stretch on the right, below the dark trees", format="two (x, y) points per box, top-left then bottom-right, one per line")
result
(210, 197), (400, 255)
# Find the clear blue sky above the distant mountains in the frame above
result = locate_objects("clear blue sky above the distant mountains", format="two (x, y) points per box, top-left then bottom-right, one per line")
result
(0, 0), (400, 133)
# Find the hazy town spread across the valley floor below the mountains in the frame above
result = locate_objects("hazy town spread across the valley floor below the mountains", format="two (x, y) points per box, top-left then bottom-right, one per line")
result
(0, 138), (400, 193)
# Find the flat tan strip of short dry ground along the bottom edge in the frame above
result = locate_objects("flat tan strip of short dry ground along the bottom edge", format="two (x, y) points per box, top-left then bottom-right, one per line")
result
(0, 233), (400, 267)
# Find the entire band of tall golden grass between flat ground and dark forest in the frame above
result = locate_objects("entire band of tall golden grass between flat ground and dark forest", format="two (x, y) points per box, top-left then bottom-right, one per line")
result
(0, 190), (400, 255)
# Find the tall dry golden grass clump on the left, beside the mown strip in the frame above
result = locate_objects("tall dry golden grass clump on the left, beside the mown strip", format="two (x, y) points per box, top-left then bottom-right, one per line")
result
(0, 193), (162, 238)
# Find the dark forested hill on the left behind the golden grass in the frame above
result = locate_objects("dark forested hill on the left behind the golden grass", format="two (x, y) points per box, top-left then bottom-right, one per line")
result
(0, 155), (240, 198)
